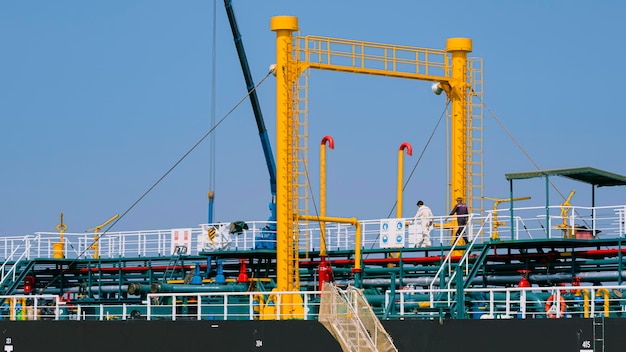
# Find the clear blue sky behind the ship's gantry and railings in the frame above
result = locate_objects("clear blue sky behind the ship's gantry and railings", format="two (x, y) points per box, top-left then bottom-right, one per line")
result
(0, 0), (626, 235)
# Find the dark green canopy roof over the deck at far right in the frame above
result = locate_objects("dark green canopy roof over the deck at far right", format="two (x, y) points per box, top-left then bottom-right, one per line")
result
(504, 166), (626, 187)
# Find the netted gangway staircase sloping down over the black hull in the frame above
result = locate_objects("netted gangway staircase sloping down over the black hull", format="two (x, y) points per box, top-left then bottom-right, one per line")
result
(319, 283), (398, 352)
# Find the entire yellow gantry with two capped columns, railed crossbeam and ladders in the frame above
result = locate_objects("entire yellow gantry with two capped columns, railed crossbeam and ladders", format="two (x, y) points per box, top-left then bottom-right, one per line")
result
(270, 16), (482, 291)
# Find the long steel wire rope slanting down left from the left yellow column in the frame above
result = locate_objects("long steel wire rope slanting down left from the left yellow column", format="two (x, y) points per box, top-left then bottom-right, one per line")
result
(40, 70), (273, 292)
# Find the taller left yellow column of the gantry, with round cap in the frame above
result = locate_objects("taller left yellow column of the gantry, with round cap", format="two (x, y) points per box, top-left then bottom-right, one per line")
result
(270, 16), (298, 291)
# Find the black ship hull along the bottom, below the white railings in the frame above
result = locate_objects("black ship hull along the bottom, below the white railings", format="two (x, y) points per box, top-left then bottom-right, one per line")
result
(0, 318), (626, 352)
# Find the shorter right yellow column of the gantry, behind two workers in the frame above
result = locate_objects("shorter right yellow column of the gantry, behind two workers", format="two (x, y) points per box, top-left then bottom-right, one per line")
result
(446, 38), (472, 205)
